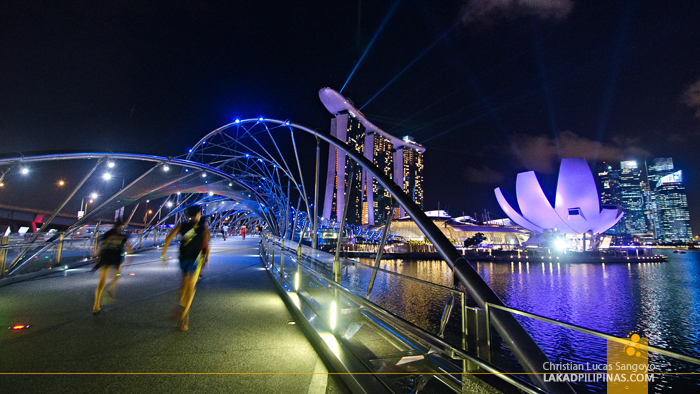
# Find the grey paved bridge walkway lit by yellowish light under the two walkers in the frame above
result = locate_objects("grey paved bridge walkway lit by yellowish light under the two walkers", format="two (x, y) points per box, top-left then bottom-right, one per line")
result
(0, 237), (348, 393)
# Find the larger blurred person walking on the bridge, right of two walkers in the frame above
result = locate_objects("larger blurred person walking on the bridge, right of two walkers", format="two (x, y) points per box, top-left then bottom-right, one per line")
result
(160, 205), (210, 331)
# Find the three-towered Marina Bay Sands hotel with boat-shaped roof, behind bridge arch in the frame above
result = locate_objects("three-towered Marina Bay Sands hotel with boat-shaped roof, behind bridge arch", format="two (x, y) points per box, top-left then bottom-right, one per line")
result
(319, 88), (425, 225)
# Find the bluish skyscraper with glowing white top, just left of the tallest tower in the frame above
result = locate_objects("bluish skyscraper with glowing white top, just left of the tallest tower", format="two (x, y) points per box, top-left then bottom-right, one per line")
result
(616, 160), (648, 237)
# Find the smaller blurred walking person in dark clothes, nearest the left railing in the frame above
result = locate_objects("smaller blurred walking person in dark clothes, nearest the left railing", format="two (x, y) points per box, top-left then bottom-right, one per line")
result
(92, 220), (132, 315)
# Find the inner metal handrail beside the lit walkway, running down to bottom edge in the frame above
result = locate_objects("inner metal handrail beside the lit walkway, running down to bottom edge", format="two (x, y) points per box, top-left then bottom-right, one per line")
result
(265, 242), (546, 394)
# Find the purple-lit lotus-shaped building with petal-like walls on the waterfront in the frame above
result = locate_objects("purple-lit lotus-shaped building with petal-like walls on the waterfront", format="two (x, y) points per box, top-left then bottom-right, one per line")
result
(494, 158), (623, 242)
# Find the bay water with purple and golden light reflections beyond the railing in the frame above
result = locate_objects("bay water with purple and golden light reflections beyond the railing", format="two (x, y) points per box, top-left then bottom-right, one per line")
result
(361, 250), (700, 392)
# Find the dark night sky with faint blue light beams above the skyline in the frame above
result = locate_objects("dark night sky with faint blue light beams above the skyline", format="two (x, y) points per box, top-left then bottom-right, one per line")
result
(0, 0), (700, 233)
